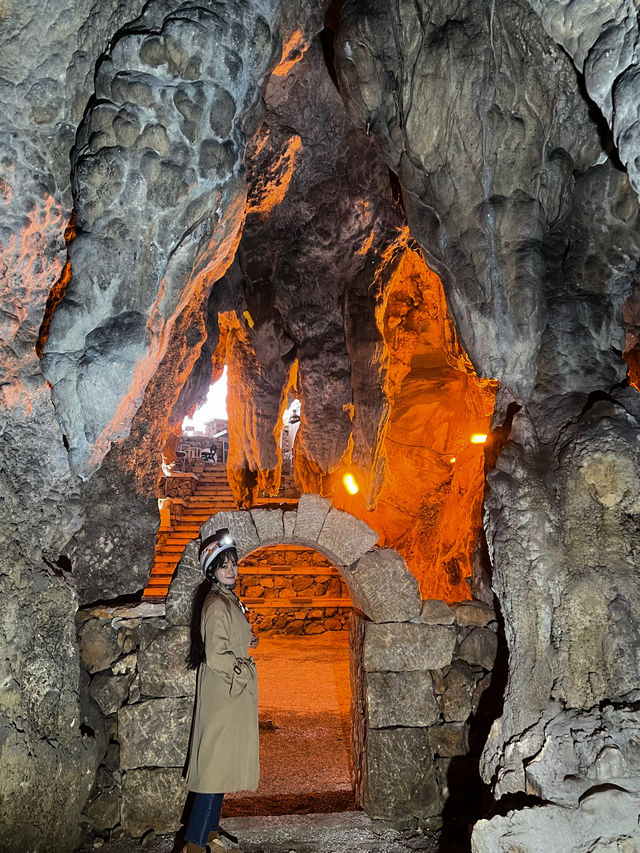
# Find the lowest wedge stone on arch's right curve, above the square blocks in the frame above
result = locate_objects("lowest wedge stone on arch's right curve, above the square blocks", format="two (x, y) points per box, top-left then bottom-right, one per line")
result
(348, 548), (420, 622)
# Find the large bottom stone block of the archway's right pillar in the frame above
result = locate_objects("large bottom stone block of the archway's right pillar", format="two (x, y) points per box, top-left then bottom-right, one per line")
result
(365, 728), (442, 820)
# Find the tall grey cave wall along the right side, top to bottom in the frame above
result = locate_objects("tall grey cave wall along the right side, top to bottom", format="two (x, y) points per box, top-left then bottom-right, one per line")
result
(337, 0), (640, 851)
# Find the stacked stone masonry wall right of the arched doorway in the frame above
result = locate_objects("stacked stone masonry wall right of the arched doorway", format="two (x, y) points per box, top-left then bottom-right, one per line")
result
(352, 600), (498, 829)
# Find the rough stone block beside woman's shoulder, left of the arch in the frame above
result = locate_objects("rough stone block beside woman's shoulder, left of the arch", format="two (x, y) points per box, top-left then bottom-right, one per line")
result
(138, 626), (196, 697)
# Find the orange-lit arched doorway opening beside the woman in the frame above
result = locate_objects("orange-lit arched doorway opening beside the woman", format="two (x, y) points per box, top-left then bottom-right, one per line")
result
(224, 544), (355, 815)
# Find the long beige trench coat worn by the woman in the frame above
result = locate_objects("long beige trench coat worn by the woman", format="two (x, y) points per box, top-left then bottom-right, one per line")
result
(186, 584), (260, 794)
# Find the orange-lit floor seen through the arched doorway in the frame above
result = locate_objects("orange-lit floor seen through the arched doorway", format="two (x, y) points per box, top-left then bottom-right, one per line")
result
(223, 631), (353, 817)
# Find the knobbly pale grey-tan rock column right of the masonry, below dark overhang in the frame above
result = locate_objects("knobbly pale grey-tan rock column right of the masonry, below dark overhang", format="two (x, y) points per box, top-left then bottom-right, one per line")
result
(482, 394), (640, 793)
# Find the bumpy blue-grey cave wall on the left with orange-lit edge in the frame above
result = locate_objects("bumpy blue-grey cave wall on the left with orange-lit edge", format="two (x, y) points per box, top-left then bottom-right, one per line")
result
(0, 0), (323, 851)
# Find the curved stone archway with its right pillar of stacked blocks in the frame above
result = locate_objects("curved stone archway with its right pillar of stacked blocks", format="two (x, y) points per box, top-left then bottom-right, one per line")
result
(166, 494), (476, 821)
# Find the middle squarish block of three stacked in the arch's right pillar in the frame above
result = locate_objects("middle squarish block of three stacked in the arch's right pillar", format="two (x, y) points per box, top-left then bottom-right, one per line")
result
(366, 672), (440, 728)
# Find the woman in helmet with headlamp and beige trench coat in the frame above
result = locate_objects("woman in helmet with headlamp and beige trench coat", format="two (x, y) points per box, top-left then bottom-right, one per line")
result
(183, 528), (259, 853)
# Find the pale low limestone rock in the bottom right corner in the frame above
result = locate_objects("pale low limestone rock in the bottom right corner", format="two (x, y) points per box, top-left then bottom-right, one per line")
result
(471, 789), (640, 853)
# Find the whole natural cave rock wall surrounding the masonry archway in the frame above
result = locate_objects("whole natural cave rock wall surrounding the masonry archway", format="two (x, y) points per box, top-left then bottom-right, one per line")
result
(0, 0), (640, 851)
